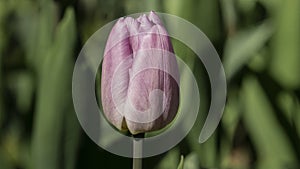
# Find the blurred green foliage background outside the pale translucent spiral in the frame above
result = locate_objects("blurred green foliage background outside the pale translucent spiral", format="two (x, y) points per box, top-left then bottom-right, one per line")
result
(0, 0), (300, 169)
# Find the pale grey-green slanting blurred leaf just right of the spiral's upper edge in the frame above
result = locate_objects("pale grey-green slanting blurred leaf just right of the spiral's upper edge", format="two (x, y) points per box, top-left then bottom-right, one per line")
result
(224, 22), (273, 80)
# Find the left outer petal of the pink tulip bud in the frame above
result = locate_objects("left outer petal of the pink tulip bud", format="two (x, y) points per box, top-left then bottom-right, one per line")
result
(101, 18), (132, 130)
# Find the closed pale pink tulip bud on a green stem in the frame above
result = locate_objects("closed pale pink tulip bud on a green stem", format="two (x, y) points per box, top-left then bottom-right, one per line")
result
(101, 12), (179, 134)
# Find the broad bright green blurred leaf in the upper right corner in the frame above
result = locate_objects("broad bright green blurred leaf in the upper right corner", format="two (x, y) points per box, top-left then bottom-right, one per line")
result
(270, 0), (300, 89)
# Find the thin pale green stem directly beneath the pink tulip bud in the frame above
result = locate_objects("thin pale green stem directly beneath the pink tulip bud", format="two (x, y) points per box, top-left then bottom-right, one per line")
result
(132, 133), (145, 169)
